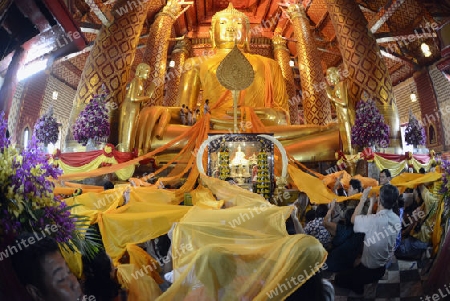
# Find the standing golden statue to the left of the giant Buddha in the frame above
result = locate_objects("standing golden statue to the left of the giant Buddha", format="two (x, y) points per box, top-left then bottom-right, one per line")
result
(118, 63), (155, 152)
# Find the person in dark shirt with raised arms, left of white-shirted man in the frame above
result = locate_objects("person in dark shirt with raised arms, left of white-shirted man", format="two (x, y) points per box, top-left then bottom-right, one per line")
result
(323, 200), (364, 272)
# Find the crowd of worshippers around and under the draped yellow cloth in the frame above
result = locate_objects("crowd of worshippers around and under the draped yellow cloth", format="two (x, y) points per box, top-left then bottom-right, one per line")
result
(4, 164), (437, 301)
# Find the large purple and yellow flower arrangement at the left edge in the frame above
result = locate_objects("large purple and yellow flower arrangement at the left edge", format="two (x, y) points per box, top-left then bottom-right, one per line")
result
(0, 112), (99, 256)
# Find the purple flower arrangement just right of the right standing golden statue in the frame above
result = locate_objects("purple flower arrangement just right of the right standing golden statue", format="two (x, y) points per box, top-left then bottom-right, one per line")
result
(351, 99), (389, 147)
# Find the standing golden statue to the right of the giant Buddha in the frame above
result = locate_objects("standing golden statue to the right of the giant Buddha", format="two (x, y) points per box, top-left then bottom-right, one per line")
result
(326, 67), (355, 154)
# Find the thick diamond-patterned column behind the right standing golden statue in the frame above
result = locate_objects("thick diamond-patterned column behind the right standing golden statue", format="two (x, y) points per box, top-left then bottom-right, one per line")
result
(325, 0), (402, 151)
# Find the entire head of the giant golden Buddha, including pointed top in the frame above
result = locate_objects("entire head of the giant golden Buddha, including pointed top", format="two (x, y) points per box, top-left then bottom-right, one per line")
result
(210, 2), (250, 51)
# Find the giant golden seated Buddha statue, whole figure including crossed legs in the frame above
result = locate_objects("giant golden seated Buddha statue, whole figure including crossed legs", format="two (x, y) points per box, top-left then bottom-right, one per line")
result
(127, 3), (339, 161)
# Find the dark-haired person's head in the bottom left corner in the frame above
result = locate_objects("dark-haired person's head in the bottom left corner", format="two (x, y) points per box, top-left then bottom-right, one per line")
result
(11, 233), (83, 301)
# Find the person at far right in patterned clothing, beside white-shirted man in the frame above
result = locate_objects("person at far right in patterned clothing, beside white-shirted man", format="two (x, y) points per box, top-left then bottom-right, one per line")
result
(395, 185), (439, 260)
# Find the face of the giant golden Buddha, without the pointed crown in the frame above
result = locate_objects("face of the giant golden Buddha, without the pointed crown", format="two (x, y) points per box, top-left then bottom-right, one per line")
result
(211, 14), (248, 49)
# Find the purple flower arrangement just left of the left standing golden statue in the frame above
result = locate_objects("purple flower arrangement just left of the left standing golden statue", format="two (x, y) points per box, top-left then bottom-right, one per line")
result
(72, 86), (110, 145)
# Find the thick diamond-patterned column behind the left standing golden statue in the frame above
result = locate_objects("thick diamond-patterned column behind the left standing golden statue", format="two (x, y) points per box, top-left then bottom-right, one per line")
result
(66, 1), (151, 144)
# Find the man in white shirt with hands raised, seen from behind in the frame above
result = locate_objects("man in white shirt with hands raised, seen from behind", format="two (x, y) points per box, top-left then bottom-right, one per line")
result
(335, 184), (401, 294)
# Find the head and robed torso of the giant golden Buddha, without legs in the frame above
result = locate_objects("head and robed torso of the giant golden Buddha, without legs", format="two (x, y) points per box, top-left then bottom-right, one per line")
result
(174, 3), (289, 124)
